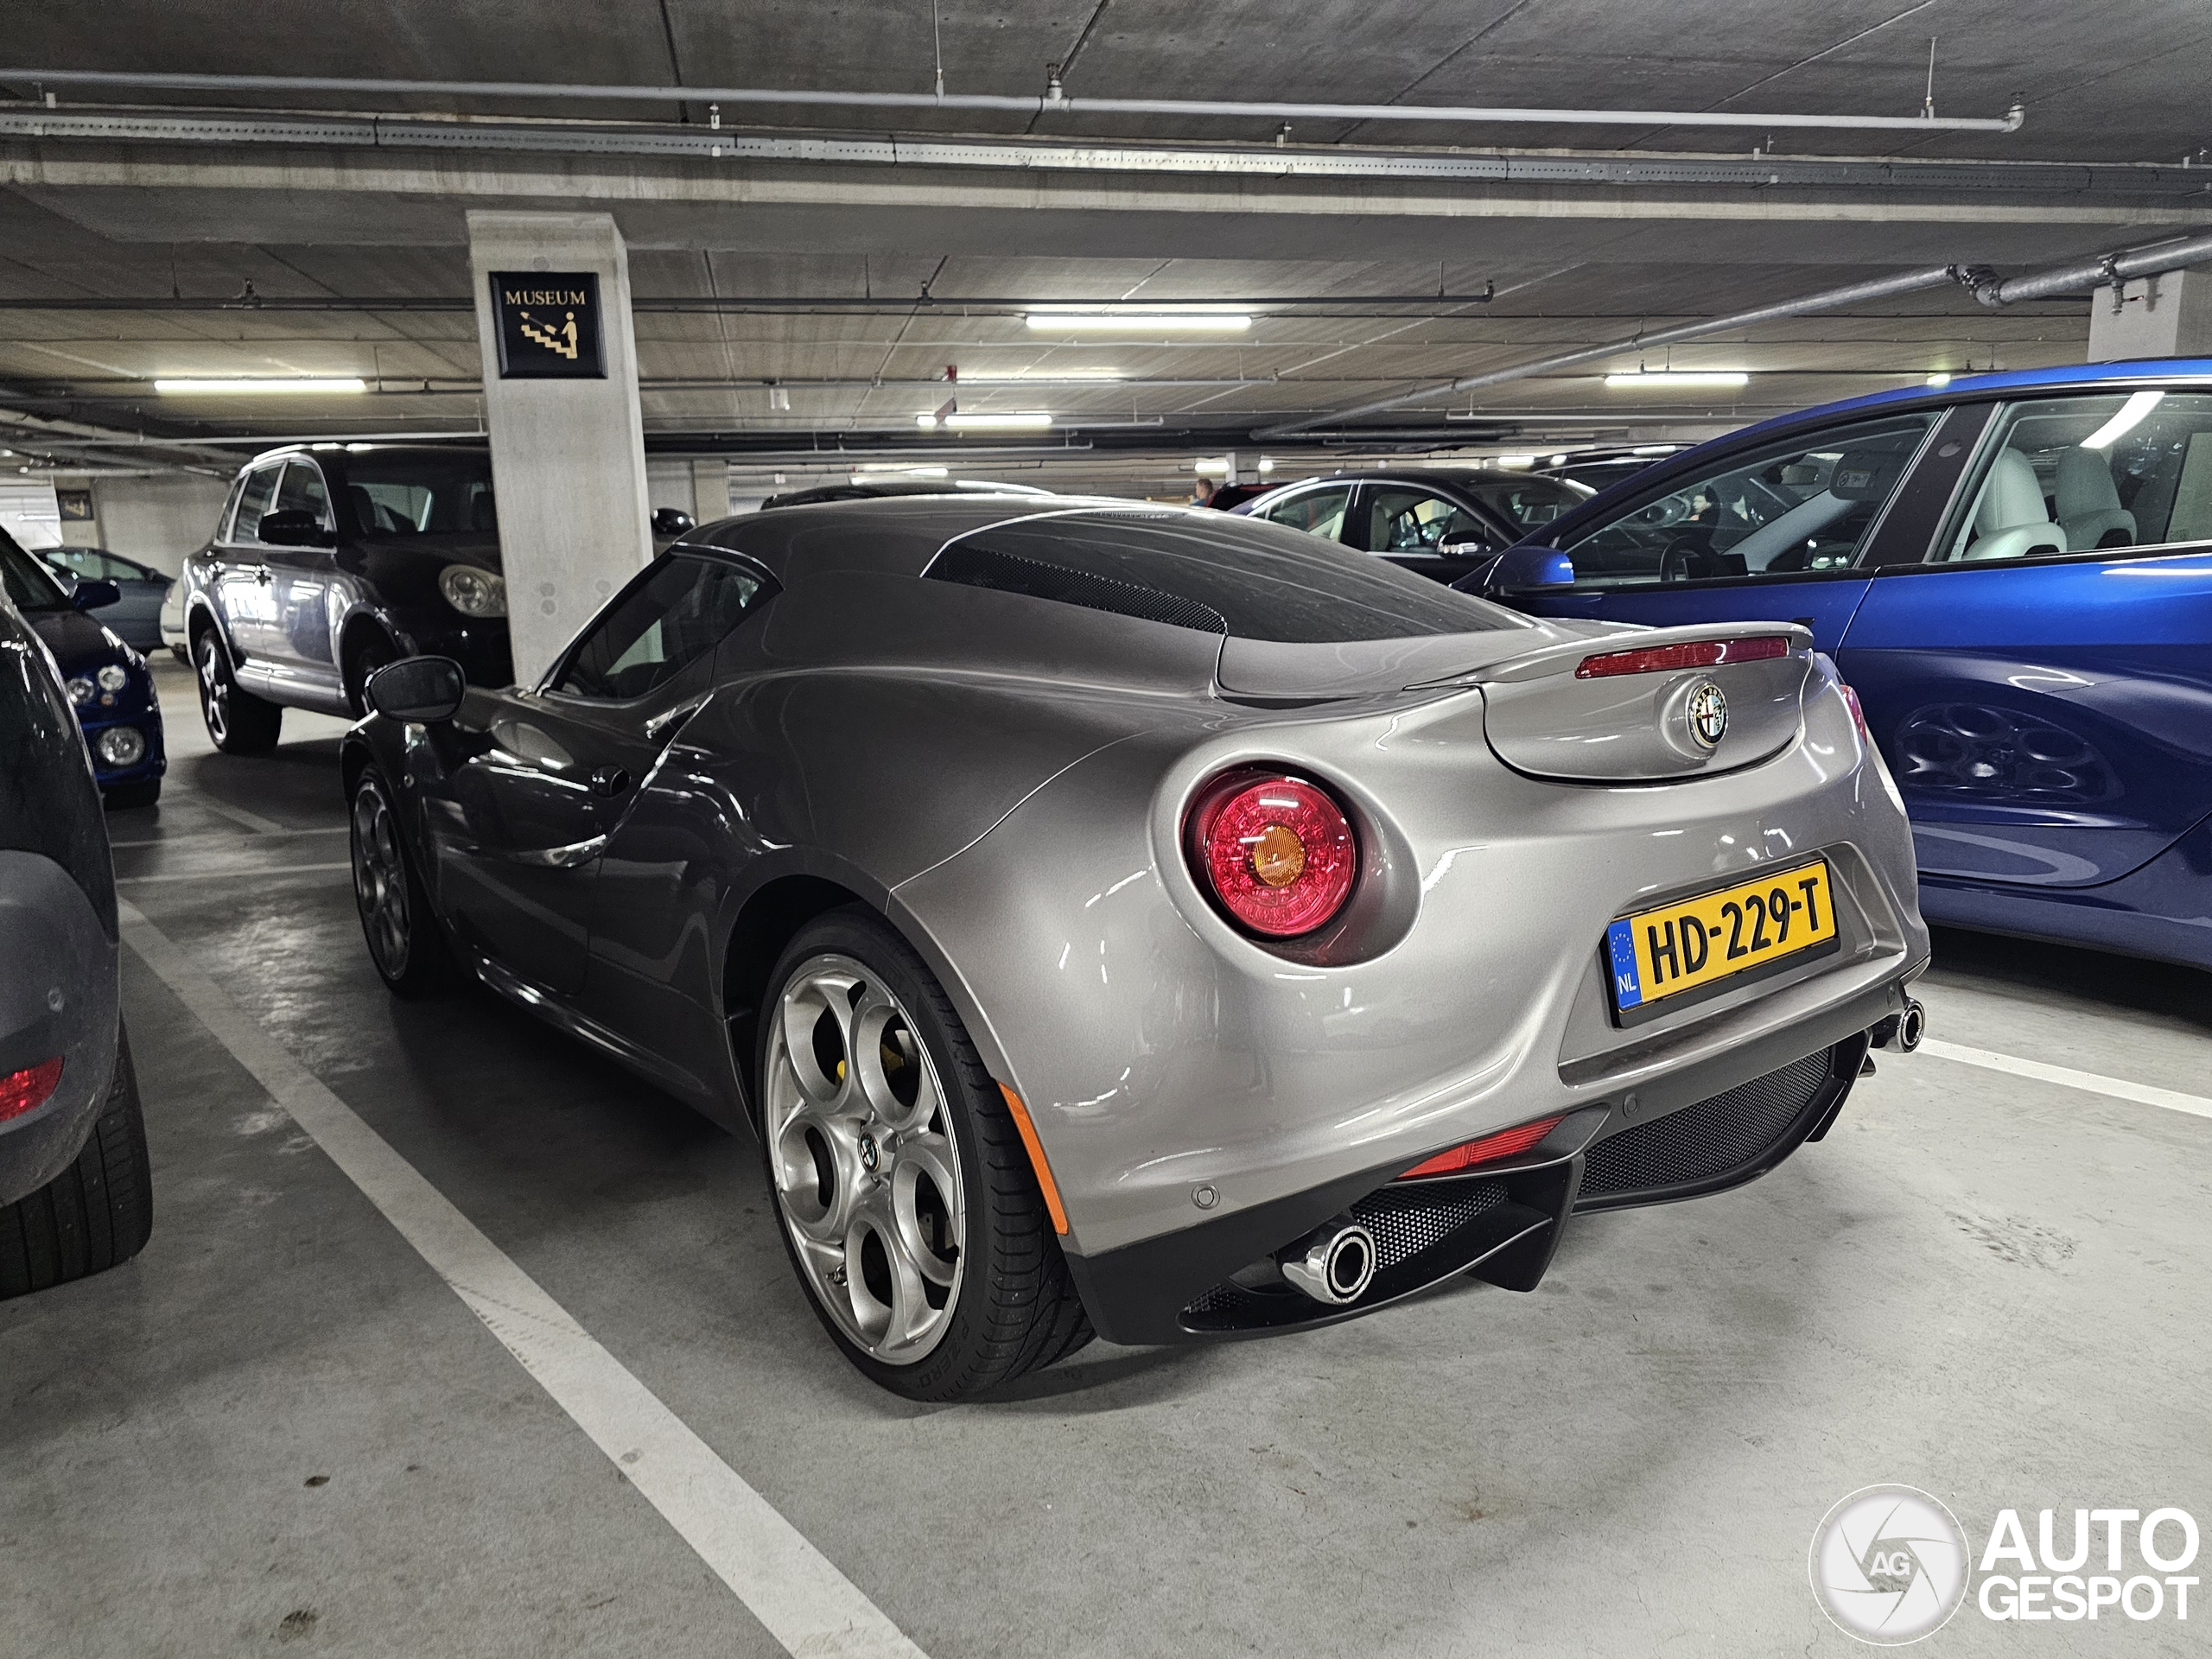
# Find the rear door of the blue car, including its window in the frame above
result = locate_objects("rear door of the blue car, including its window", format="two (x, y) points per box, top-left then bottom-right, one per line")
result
(1838, 390), (2212, 887)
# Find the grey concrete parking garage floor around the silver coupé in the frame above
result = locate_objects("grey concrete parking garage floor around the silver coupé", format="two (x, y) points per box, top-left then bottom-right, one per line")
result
(0, 668), (2212, 1659)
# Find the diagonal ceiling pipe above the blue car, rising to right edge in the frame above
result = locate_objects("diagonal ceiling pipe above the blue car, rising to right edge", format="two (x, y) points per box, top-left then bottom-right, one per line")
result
(1252, 237), (2212, 442)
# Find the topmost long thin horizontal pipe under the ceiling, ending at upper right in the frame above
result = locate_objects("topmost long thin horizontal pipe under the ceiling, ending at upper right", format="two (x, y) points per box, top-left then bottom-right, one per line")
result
(0, 68), (2029, 133)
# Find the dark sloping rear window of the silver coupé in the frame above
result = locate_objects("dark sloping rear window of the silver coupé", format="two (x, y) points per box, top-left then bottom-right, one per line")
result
(923, 511), (1516, 646)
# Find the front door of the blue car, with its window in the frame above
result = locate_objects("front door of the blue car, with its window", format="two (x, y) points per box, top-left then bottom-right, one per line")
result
(1513, 404), (1988, 652)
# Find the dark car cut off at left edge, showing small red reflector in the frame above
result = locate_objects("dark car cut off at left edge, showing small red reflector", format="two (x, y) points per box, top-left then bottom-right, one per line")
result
(0, 579), (153, 1299)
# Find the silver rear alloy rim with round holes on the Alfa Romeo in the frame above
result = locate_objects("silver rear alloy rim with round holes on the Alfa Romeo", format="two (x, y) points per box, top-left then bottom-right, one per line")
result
(763, 953), (967, 1365)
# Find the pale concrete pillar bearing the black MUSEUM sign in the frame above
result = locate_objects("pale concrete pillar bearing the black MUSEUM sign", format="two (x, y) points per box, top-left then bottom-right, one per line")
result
(469, 213), (652, 686)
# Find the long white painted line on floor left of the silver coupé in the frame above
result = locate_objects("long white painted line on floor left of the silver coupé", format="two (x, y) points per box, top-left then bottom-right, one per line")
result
(118, 902), (925, 1659)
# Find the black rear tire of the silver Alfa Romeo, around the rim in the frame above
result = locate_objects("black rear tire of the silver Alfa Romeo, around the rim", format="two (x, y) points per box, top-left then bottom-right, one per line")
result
(754, 905), (1090, 1400)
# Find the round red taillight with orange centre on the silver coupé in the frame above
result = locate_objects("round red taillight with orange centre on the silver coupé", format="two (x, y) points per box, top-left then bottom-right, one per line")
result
(1190, 772), (1360, 938)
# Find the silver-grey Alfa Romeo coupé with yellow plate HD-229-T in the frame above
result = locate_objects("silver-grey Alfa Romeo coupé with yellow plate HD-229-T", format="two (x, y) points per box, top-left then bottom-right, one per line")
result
(345, 495), (1929, 1400)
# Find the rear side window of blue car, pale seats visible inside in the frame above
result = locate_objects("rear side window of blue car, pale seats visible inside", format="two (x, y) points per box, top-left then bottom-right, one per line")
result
(1933, 387), (2212, 564)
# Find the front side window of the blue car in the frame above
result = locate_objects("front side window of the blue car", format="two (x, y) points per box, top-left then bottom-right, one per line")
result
(1564, 410), (1942, 588)
